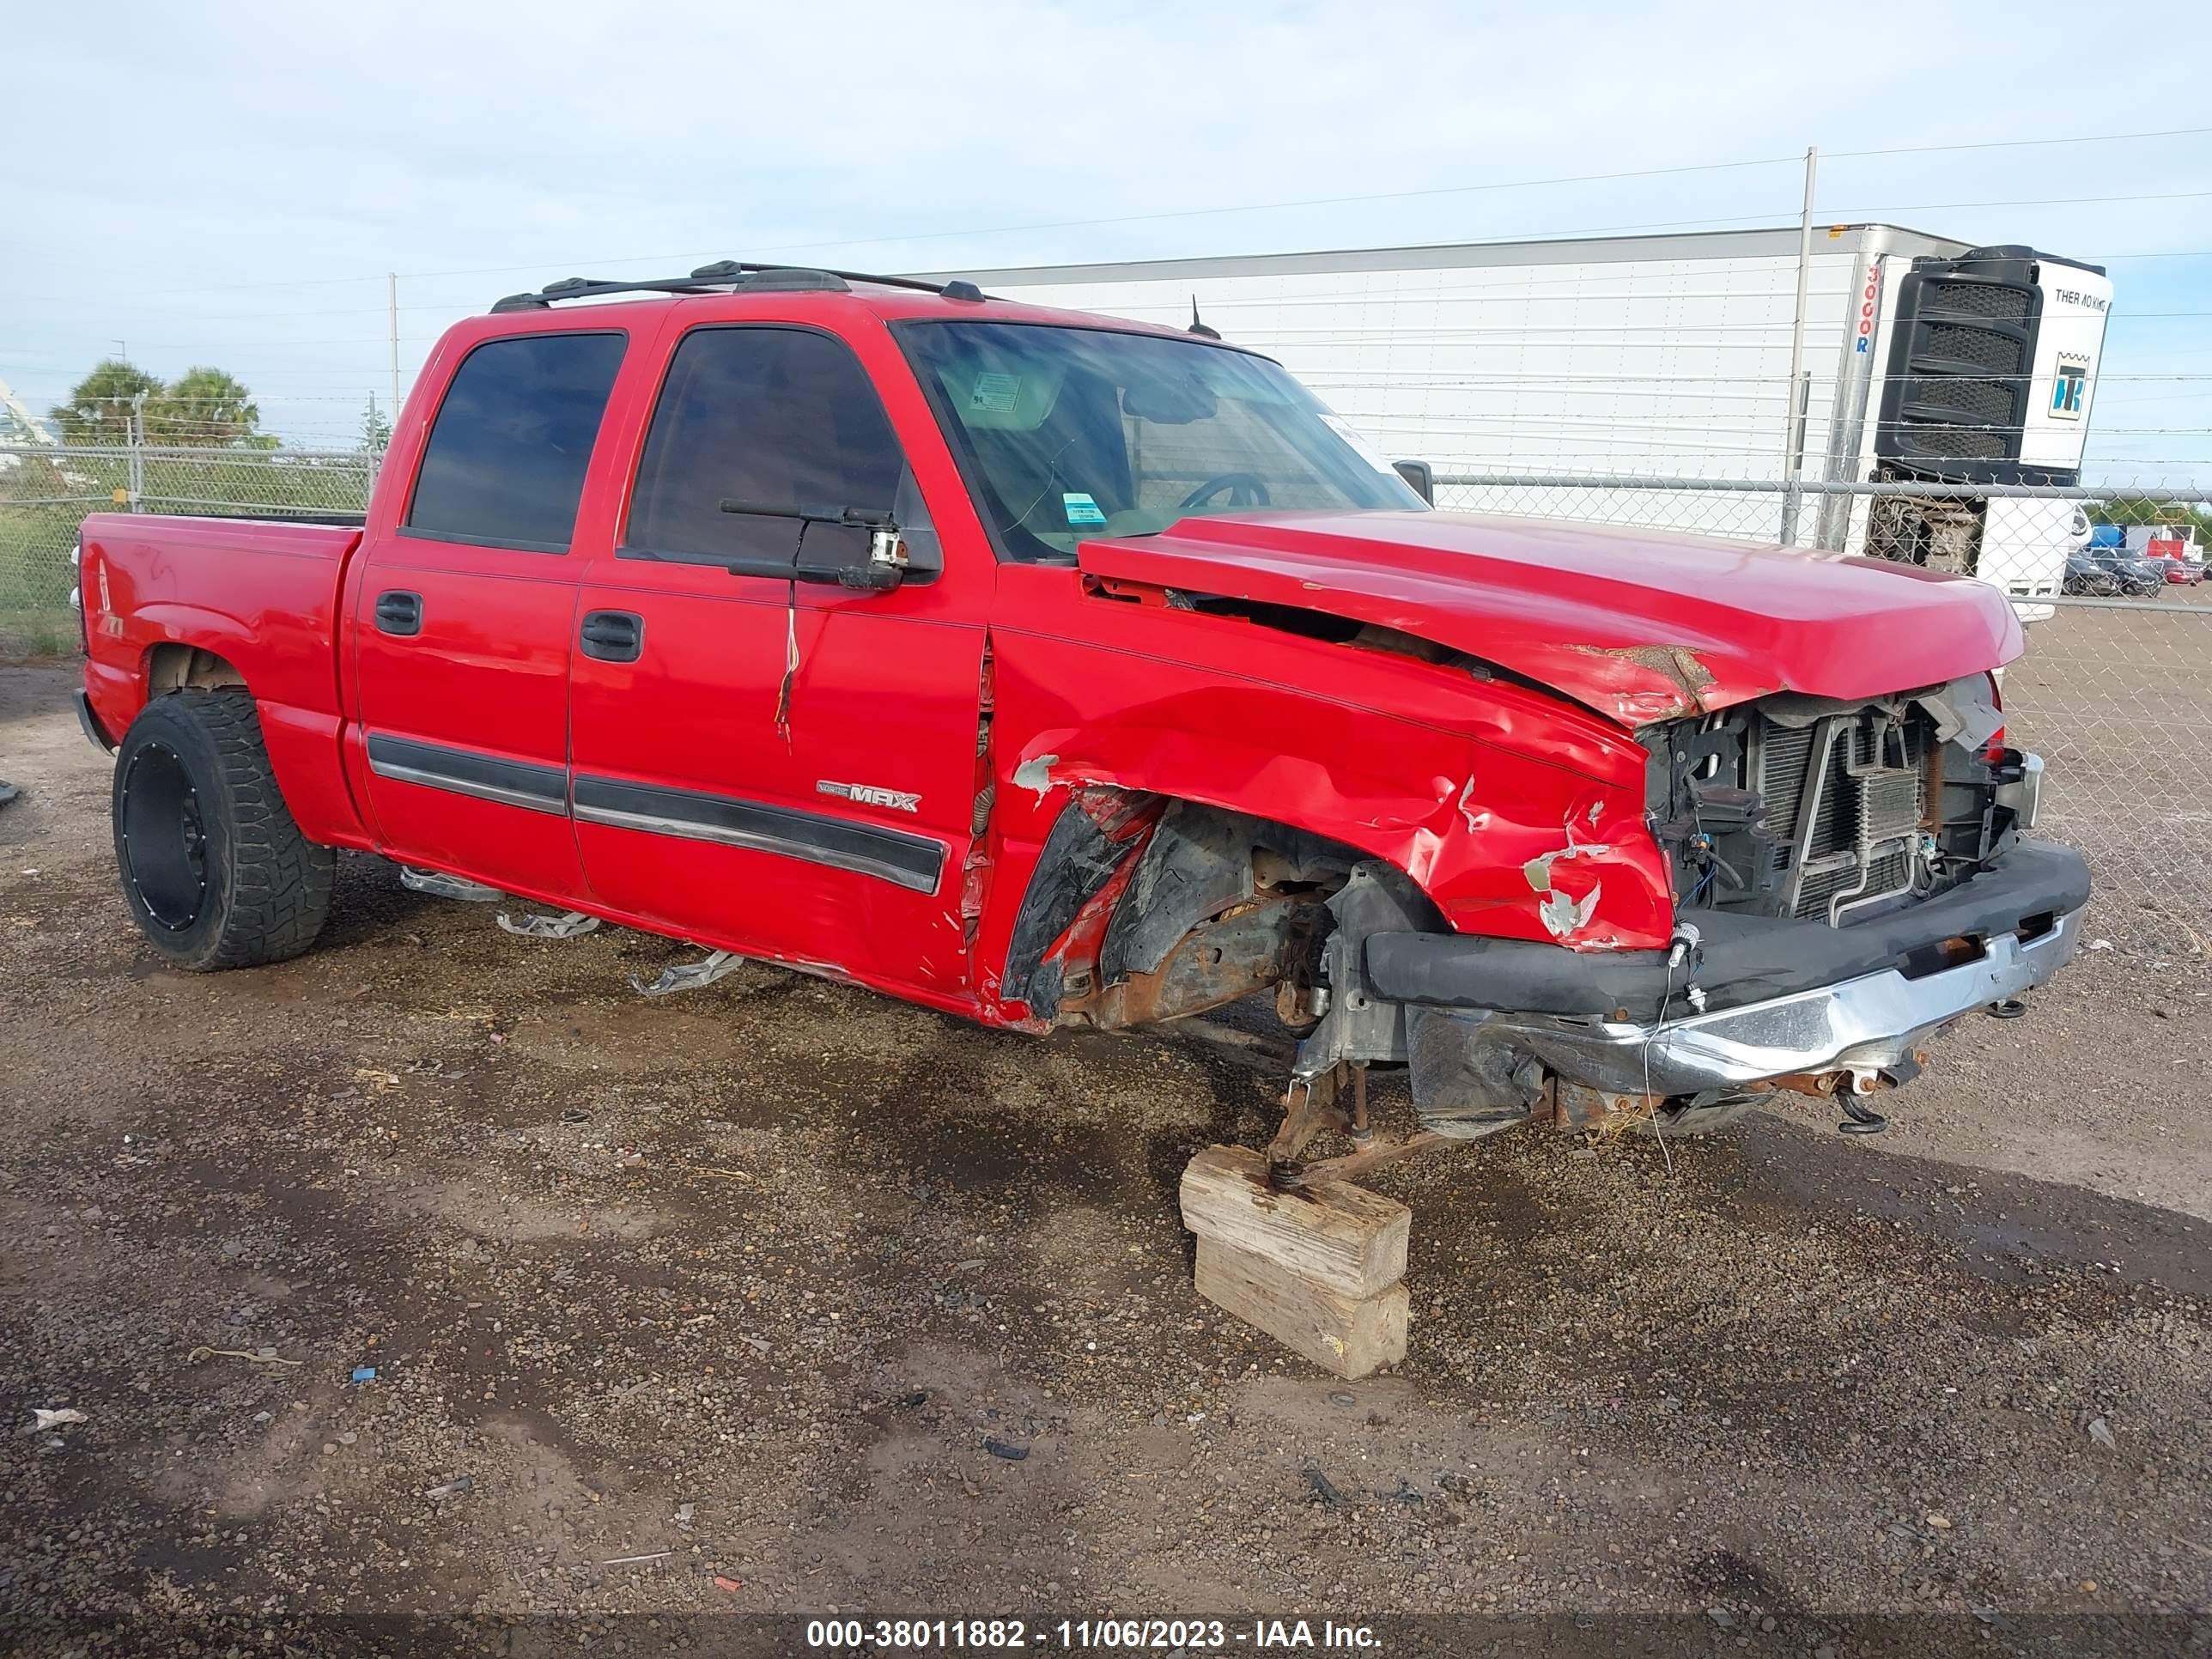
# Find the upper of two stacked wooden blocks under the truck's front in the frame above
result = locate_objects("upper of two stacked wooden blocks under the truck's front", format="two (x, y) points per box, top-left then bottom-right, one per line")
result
(1182, 1146), (1413, 1300)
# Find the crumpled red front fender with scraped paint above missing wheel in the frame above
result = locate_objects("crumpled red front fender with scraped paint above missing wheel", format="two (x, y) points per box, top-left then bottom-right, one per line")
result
(978, 633), (1672, 1022)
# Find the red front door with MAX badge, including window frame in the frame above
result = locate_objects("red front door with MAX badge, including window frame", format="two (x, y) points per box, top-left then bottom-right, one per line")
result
(571, 313), (991, 998)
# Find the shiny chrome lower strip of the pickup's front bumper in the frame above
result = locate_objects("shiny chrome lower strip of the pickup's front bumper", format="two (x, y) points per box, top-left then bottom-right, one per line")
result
(1482, 911), (2081, 1095)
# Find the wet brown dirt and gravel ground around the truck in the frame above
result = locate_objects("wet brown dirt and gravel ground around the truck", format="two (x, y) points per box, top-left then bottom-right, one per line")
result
(0, 665), (2212, 1659)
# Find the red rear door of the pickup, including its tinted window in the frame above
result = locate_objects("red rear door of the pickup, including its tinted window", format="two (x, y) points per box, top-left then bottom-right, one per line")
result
(349, 327), (626, 898)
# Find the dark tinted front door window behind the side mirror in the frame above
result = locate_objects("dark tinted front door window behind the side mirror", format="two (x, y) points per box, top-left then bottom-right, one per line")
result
(623, 327), (905, 562)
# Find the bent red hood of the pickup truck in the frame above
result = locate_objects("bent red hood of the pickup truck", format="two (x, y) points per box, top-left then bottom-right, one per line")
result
(1078, 514), (2021, 726)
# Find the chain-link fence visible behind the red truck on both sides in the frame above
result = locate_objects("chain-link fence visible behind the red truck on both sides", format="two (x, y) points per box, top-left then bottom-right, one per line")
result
(0, 445), (2212, 953)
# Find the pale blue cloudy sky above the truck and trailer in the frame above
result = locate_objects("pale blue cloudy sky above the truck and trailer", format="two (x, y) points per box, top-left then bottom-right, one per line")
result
(0, 0), (2212, 476)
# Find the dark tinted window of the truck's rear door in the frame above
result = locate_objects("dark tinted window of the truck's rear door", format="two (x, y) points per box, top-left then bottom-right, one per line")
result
(407, 334), (626, 553)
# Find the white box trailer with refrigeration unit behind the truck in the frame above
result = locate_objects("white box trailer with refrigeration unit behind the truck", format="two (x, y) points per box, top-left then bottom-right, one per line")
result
(940, 223), (2112, 617)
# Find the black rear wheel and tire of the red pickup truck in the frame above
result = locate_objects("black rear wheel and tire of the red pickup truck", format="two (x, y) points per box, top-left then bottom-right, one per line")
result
(112, 690), (338, 973)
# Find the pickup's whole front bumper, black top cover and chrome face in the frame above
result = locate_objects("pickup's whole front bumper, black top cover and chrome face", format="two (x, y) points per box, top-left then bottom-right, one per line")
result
(1298, 841), (2090, 1128)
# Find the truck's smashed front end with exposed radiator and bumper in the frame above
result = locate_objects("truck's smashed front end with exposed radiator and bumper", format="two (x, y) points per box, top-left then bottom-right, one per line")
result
(1294, 675), (2090, 1137)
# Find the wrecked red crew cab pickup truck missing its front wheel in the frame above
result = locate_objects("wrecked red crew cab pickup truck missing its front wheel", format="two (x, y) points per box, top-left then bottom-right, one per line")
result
(64, 264), (2088, 1152)
